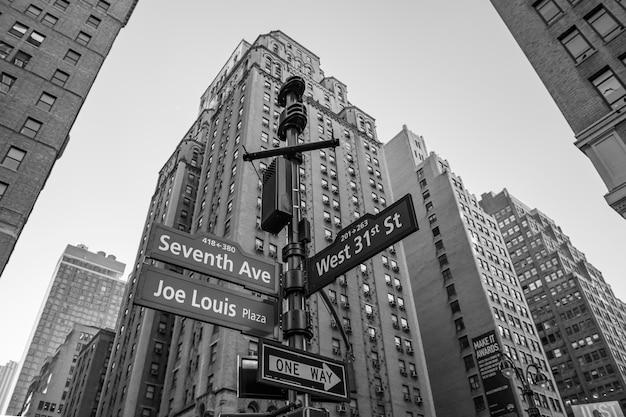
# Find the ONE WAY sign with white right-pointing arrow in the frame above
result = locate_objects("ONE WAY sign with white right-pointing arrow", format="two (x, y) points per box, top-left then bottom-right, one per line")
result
(257, 339), (350, 401)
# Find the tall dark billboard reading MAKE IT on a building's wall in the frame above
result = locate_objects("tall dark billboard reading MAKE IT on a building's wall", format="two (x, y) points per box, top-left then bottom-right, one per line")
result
(472, 330), (521, 417)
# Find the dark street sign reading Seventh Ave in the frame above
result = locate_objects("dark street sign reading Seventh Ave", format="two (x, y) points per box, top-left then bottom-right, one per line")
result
(146, 223), (279, 296)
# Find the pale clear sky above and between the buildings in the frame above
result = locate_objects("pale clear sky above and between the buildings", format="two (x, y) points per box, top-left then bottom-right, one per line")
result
(0, 0), (626, 364)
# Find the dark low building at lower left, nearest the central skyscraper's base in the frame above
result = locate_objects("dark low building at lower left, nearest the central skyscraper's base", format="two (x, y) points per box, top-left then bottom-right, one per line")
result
(63, 329), (115, 417)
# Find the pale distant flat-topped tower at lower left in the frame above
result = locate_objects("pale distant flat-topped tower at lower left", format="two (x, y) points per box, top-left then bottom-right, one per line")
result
(7, 245), (125, 415)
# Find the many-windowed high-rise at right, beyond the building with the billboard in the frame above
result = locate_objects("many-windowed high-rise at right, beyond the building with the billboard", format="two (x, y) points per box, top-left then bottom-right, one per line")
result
(480, 189), (626, 409)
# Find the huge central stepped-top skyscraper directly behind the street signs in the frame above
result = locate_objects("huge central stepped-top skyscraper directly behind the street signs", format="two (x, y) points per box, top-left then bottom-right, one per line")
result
(98, 31), (434, 417)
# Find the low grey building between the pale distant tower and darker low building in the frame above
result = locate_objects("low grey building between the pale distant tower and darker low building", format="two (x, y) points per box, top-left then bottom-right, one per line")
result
(19, 324), (99, 417)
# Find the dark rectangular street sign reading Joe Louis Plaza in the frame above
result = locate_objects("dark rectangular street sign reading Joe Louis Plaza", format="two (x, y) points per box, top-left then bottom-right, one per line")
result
(134, 265), (278, 338)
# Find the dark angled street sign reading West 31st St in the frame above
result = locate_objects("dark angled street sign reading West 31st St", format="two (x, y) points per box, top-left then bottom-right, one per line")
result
(307, 194), (418, 295)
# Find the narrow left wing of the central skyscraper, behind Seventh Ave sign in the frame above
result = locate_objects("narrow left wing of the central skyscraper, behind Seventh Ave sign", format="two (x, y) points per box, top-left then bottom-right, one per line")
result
(98, 130), (204, 417)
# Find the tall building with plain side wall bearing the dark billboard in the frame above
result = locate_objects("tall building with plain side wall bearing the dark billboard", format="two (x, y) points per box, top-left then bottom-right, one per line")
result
(384, 126), (565, 416)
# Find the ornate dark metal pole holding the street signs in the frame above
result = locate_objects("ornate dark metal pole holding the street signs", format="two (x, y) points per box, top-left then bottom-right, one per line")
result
(278, 76), (312, 406)
